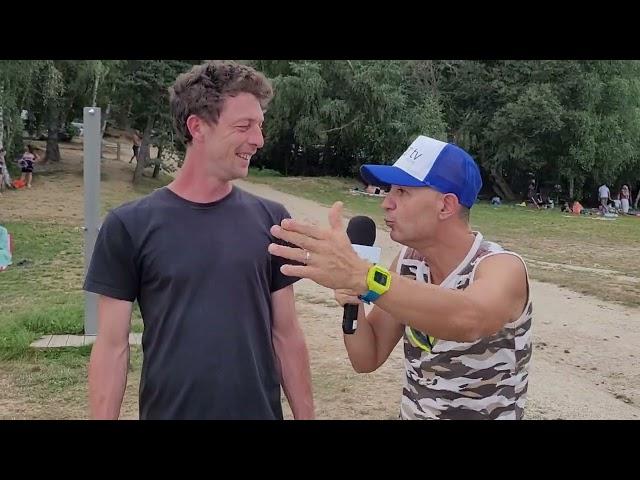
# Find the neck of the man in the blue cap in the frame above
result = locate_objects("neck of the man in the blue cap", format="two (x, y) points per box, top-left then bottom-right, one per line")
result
(416, 228), (476, 285)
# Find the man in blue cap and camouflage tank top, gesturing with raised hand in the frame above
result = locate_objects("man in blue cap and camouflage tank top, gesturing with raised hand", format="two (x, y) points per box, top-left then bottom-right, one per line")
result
(269, 136), (532, 419)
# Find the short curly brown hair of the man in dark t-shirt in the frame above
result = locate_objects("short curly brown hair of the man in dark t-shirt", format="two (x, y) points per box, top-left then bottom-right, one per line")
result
(169, 60), (273, 143)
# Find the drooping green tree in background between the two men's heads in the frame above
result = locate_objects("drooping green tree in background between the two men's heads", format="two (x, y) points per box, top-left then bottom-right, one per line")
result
(251, 60), (446, 175)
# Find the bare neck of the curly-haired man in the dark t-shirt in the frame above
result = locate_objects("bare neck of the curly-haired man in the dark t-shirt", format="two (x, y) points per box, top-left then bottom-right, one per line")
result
(167, 151), (233, 203)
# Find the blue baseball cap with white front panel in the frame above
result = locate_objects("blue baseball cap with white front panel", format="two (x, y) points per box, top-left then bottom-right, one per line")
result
(360, 135), (482, 208)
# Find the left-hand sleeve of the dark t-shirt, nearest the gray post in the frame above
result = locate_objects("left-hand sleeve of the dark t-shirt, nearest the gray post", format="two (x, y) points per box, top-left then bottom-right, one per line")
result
(84, 212), (139, 302)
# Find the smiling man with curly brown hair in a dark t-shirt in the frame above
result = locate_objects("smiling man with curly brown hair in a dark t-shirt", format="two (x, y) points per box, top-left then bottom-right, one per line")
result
(84, 61), (314, 419)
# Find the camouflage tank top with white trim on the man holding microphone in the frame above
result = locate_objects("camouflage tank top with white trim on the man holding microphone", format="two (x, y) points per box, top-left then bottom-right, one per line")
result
(397, 232), (533, 420)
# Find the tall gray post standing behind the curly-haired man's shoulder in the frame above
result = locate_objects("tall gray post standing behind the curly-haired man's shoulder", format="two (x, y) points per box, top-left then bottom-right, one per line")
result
(83, 107), (102, 335)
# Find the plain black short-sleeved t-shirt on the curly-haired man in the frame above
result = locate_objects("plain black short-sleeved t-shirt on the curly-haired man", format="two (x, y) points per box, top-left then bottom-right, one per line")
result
(84, 186), (298, 419)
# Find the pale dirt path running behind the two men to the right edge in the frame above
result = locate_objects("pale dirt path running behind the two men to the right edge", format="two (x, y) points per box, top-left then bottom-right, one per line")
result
(237, 181), (640, 419)
